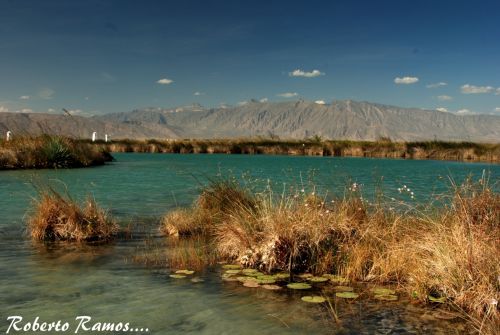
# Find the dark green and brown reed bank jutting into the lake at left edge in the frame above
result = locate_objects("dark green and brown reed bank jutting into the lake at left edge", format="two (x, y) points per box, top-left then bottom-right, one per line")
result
(0, 135), (113, 170)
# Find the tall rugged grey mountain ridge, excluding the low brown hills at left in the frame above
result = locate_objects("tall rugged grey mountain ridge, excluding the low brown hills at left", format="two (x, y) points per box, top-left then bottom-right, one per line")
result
(98, 101), (500, 142)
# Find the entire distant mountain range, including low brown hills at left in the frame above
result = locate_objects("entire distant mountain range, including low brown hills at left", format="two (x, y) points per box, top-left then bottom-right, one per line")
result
(0, 100), (500, 142)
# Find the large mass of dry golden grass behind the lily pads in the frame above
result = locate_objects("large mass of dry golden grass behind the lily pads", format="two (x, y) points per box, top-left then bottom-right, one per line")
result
(163, 178), (500, 334)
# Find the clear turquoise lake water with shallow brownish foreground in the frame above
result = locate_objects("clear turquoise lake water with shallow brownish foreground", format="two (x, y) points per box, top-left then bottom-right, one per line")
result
(0, 154), (500, 334)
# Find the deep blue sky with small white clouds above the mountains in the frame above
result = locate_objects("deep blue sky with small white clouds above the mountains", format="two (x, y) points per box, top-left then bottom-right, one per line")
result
(0, 0), (500, 115)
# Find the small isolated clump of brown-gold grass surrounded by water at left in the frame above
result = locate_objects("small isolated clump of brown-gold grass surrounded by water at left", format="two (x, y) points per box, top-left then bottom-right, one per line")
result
(28, 189), (118, 242)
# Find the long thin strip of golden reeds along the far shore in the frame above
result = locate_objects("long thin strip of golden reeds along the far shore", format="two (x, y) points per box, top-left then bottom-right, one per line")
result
(93, 139), (500, 163)
